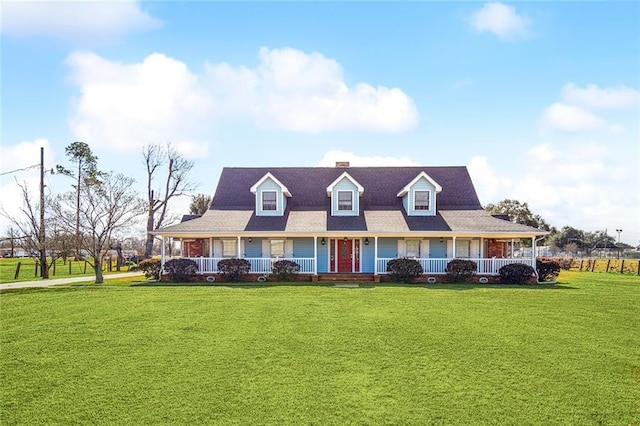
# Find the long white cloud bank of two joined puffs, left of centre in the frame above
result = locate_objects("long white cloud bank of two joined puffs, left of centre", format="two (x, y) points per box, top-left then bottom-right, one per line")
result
(68, 48), (418, 155)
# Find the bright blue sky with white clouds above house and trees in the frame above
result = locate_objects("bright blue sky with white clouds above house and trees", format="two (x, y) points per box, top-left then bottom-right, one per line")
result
(0, 0), (640, 246)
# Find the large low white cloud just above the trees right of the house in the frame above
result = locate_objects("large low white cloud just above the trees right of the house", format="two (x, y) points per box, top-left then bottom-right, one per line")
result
(467, 141), (640, 244)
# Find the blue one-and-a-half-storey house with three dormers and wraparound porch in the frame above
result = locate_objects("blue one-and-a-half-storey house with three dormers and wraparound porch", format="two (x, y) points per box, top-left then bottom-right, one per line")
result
(153, 163), (547, 276)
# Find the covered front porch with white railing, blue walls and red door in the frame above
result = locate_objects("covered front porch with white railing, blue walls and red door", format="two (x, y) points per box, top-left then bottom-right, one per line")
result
(161, 234), (537, 275)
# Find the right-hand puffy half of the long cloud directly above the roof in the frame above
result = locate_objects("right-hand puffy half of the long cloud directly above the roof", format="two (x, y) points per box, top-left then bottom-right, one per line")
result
(207, 47), (419, 133)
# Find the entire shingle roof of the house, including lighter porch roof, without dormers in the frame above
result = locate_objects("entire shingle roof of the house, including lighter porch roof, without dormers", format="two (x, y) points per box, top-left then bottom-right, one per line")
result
(149, 167), (545, 236)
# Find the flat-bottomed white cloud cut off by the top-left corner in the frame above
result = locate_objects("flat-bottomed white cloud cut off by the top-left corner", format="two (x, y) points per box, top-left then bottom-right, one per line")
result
(1, 0), (161, 41)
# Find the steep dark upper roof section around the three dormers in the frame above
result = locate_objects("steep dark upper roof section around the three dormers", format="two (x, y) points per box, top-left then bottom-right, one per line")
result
(211, 166), (482, 211)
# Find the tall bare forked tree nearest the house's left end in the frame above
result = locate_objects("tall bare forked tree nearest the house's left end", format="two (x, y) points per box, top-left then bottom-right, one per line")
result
(142, 143), (197, 258)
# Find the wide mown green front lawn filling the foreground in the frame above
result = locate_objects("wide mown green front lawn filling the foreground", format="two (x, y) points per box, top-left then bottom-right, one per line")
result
(0, 271), (640, 425)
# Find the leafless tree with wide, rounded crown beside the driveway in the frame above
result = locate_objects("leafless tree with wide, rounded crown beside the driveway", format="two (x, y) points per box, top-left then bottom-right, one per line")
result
(52, 173), (145, 284)
